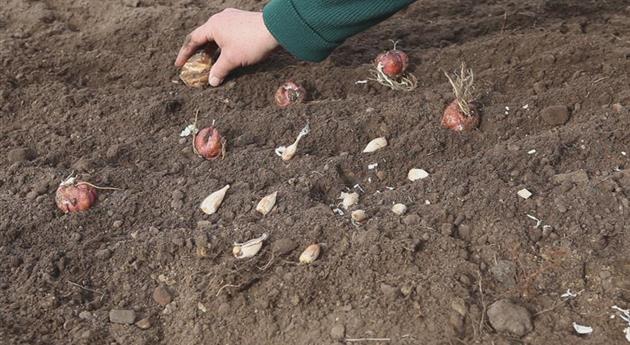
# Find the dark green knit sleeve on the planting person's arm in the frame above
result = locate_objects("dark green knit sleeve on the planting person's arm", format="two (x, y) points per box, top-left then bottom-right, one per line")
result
(263, 0), (415, 61)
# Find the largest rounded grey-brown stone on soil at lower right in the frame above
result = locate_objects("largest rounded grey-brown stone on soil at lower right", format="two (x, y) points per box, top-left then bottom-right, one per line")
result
(488, 299), (533, 337)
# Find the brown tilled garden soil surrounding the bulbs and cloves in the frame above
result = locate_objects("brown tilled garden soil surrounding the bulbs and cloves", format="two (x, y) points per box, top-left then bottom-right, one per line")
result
(0, 0), (630, 345)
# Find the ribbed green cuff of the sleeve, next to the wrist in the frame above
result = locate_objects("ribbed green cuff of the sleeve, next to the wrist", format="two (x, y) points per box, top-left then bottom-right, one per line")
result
(263, 0), (339, 62)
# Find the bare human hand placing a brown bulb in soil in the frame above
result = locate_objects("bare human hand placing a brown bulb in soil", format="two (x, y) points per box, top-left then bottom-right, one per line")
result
(175, 8), (278, 86)
